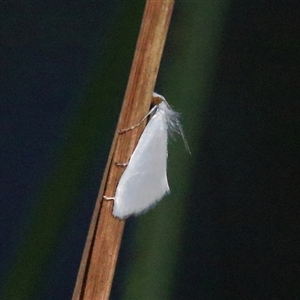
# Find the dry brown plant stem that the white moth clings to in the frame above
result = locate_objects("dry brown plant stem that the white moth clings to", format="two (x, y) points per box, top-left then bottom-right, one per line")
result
(72, 0), (174, 300)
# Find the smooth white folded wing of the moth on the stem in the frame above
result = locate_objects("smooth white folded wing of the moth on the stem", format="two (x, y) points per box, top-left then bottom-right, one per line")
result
(113, 110), (169, 219)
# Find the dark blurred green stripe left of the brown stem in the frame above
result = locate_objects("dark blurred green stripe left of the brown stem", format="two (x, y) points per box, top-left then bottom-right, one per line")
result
(0, 0), (144, 300)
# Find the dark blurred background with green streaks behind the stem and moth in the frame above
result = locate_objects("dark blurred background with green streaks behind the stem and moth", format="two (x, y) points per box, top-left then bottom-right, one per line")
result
(0, 0), (300, 300)
